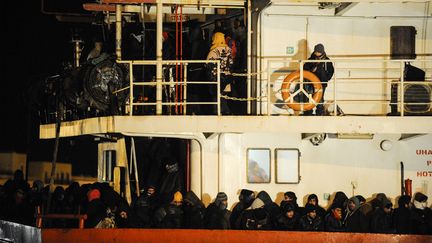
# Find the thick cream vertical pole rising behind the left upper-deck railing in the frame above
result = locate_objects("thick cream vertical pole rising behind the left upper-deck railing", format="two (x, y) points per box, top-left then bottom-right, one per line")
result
(156, 0), (163, 115)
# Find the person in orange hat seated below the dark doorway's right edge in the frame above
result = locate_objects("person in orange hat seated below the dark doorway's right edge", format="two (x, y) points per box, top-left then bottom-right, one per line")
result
(154, 191), (183, 229)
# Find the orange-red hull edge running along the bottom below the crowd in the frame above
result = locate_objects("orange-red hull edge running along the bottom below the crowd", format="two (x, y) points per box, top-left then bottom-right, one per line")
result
(42, 229), (432, 243)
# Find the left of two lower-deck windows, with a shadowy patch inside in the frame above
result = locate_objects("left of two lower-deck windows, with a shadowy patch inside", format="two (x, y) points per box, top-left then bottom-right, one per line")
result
(247, 148), (270, 183)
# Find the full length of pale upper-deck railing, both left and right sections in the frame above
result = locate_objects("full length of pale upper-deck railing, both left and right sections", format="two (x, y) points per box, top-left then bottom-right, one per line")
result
(116, 58), (432, 116)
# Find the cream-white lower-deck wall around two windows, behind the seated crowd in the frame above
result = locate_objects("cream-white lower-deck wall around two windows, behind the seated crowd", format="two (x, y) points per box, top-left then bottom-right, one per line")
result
(191, 133), (432, 208)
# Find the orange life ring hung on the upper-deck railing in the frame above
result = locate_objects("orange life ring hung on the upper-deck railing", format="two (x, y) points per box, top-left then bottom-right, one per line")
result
(281, 71), (323, 111)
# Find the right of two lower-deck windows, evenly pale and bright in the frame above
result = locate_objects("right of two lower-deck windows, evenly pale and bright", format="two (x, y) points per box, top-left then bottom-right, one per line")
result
(275, 149), (300, 184)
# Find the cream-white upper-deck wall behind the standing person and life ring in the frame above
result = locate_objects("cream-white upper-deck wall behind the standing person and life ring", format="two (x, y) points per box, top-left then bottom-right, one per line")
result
(261, 3), (432, 114)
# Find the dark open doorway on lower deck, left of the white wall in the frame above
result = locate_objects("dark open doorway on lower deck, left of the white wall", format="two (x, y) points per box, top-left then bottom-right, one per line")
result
(126, 137), (190, 203)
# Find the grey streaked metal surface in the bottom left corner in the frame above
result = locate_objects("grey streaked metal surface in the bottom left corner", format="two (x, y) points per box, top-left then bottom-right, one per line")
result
(0, 220), (42, 243)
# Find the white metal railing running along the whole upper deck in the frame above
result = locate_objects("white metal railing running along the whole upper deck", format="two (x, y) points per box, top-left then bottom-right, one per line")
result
(115, 58), (432, 116)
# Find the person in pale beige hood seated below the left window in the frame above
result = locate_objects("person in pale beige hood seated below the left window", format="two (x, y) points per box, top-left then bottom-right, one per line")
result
(241, 198), (272, 230)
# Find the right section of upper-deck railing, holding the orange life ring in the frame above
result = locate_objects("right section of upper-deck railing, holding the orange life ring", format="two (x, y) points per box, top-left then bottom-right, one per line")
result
(264, 58), (432, 116)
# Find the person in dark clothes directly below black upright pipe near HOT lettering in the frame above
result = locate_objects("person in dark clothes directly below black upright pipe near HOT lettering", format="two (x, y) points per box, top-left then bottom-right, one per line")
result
(393, 195), (411, 234)
